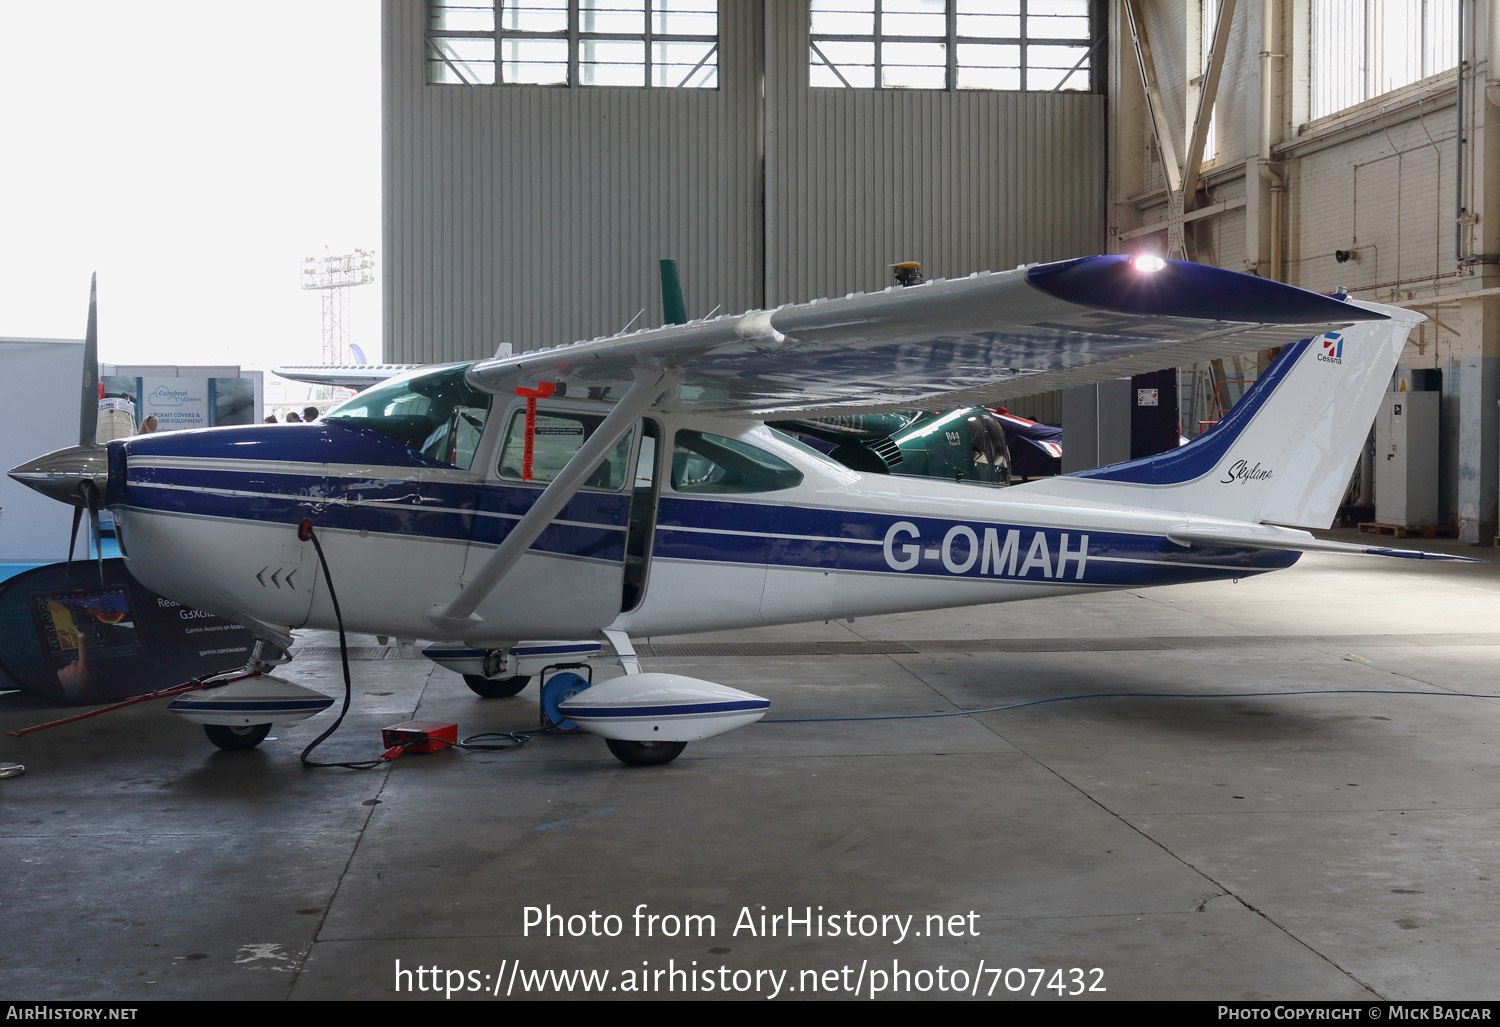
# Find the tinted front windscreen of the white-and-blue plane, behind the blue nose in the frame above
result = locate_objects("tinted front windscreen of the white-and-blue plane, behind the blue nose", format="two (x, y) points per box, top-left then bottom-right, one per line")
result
(324, 367), (492, 471)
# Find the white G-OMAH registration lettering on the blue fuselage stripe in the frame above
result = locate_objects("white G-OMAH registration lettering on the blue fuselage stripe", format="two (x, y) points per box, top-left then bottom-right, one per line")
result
(885, 520), (1089, 580)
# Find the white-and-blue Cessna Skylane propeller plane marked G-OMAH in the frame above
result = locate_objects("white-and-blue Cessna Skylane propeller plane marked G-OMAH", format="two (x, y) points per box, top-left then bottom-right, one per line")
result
(2, 256), (1452, 762)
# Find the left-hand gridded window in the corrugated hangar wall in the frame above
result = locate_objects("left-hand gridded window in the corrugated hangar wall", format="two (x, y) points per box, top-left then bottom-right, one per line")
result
(426, 0), (719, 88)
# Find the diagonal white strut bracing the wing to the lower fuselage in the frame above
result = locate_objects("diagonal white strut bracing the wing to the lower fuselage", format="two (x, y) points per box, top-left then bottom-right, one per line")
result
(426, 369), (675, 631)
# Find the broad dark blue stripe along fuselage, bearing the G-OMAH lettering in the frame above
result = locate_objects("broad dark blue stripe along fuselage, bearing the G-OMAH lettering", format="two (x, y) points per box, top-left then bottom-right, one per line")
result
(123, 459), (1298, 584)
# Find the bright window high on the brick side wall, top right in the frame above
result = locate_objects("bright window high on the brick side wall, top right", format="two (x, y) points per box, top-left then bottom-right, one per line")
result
(1311, 0), (1458, 118)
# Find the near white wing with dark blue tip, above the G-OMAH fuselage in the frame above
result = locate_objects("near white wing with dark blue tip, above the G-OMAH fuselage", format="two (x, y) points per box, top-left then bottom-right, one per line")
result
(470, 255), (1385, 417)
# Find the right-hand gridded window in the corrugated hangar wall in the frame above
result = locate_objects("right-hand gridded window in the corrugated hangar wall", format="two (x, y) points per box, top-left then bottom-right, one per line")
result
(807, 0), (1101, 91)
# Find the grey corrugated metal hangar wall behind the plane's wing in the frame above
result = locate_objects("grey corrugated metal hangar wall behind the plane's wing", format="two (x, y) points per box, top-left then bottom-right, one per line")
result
(383, 0), (1106, 361)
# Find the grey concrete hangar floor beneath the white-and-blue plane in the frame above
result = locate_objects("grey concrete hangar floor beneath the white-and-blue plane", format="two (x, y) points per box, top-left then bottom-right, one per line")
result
(0, 535), (1500, 1000)
